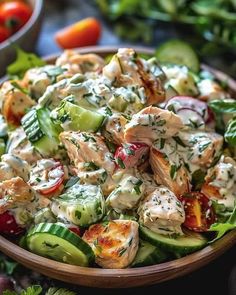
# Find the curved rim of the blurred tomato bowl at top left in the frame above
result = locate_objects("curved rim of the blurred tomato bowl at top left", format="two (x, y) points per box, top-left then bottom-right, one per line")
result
(0, 0), (44, 50)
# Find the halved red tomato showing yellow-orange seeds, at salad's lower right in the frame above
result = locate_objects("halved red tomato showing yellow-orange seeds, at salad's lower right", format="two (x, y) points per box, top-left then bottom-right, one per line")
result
(179, 192), (216, 232)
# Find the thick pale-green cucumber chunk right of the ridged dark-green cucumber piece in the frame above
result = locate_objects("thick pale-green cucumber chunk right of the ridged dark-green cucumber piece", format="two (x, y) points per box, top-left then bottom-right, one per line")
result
(52, 100), (105, 132)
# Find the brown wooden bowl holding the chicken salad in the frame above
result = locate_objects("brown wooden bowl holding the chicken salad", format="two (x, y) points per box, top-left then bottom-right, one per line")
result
(0, 47), (236, 288)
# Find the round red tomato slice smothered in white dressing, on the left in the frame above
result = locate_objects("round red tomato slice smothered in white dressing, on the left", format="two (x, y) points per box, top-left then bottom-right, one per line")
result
(29, 159), (65, 195)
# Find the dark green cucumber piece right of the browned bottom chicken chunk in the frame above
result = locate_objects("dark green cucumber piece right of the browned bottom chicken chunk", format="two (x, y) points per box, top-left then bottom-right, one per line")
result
(131, 240), (169, 267)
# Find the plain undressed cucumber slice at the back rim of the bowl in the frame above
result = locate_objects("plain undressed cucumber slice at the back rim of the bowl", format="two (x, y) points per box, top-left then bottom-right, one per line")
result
(156, 39), (200, 73)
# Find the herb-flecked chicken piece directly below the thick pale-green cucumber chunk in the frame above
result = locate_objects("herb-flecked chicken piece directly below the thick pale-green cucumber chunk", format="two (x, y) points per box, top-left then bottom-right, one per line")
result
(60, 131), (115, 174)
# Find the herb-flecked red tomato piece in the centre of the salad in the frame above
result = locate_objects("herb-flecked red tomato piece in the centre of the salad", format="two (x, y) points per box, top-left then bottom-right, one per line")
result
(114, 143), (149, 169)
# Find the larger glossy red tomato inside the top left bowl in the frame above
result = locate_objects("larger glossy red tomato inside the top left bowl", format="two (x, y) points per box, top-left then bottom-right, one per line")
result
(0, 1), (32, 33)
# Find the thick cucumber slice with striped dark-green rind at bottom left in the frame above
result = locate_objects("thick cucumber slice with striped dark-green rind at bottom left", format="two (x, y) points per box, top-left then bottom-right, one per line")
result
(26, 223), (94, 266)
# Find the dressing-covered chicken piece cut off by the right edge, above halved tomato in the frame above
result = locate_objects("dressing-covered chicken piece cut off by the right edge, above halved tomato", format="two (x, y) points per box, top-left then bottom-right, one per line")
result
(201, 156), (236, 209)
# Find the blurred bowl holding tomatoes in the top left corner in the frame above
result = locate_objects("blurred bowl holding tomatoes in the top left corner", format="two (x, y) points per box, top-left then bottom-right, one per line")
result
(0, 0), (43, 77)
